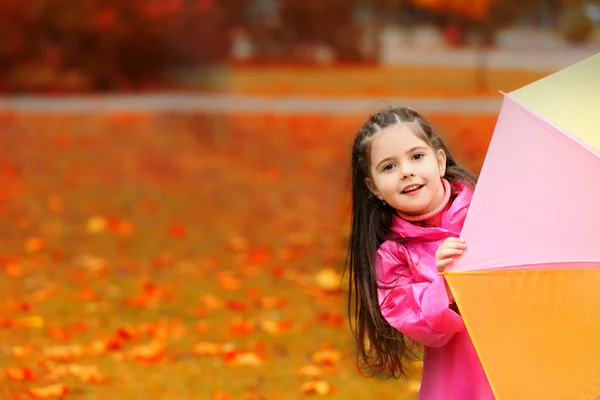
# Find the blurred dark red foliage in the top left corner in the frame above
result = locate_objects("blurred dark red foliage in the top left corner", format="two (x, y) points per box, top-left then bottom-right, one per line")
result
(0, 0), (246, 91)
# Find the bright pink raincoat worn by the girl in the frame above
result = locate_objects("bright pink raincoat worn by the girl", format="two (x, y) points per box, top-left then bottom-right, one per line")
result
(375, 183), (494, 400)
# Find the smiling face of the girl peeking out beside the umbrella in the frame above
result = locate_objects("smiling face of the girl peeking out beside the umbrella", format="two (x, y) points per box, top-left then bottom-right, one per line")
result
(365, 124), (446, 215)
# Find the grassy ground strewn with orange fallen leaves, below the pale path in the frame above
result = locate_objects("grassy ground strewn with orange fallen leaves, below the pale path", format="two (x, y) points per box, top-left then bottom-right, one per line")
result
(0, 110), (495, 400)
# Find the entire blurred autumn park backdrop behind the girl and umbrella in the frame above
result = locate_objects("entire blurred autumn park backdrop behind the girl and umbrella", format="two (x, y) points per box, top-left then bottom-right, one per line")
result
(0, 0), (600, 400)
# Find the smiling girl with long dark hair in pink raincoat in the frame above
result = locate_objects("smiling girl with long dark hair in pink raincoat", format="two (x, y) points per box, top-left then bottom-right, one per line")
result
(348, 108), (494, 400)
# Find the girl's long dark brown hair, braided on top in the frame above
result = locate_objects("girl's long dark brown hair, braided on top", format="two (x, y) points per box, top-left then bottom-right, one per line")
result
(347, 108), (477, 378)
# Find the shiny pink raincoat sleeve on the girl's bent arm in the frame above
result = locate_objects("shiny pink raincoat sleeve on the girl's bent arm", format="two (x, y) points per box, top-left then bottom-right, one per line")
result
(375, 244), (466, 347)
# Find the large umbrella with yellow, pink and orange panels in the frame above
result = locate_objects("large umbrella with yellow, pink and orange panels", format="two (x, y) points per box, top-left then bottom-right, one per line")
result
(444, 54), (600, 400)
